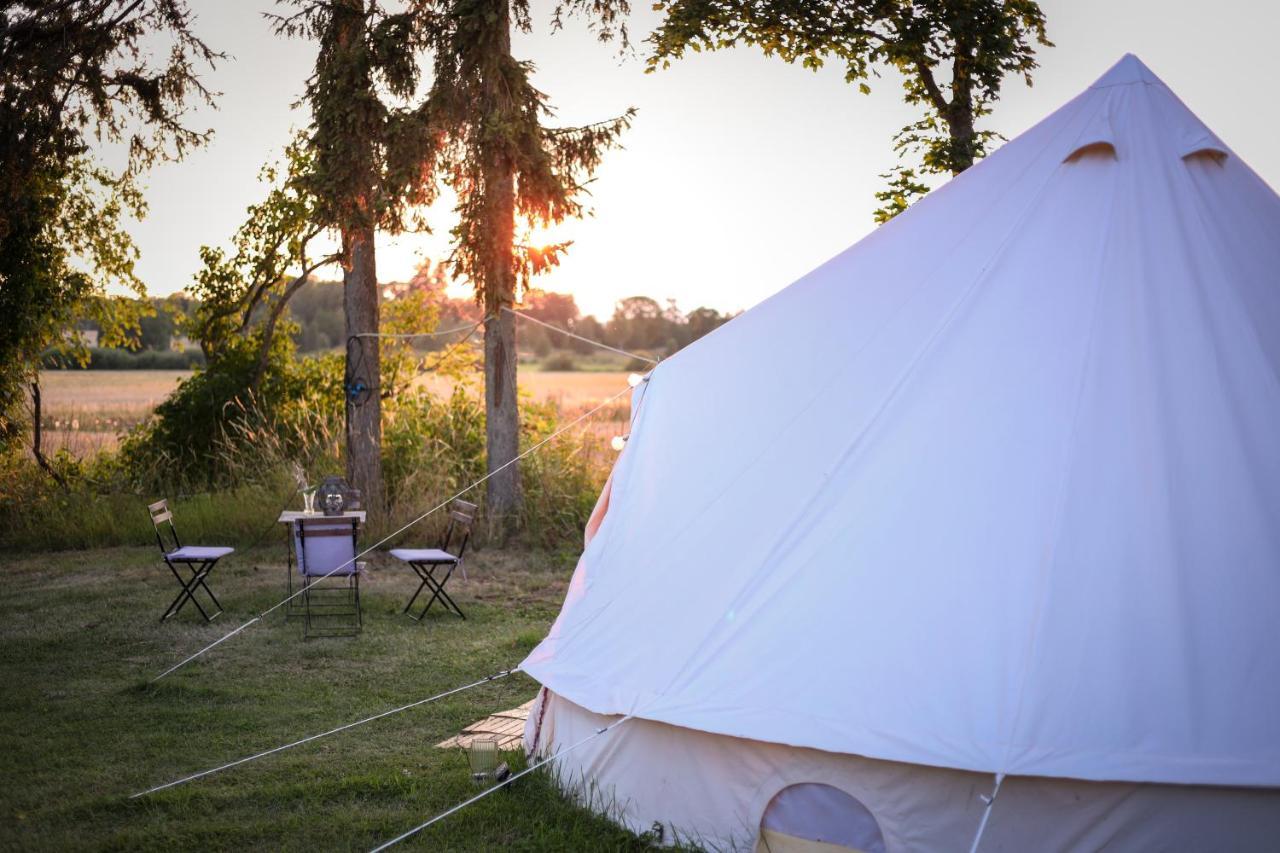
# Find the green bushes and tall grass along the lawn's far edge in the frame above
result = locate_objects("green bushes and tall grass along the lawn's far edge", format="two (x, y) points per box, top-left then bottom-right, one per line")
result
(0, 342), (614, 551)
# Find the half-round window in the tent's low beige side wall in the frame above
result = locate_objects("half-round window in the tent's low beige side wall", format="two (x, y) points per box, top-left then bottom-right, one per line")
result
(755, 783), (884, 853)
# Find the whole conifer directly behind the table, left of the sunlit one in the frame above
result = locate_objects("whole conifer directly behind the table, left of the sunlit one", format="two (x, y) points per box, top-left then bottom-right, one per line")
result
(275, 0), (438, 506)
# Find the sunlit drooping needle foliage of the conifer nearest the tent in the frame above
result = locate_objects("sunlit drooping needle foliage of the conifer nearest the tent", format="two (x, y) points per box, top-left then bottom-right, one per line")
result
(429, 0), (635, 306)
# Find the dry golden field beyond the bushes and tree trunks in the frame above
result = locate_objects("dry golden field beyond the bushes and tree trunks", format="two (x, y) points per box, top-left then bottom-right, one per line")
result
(40, 370), (627, 456)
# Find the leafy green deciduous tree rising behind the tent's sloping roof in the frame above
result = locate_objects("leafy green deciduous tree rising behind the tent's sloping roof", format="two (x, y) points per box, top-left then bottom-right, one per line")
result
(649, 0), (1052, 216)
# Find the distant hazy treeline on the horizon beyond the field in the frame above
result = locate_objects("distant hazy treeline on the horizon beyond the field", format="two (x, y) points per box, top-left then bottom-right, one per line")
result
(44, 282), (735, 370)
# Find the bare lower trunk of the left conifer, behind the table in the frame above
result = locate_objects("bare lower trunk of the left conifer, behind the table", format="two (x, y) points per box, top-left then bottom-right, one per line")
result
(342, 227), (385, 508)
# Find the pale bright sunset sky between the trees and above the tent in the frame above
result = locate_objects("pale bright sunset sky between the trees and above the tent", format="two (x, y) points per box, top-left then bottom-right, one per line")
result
(115, 0), (1280, 316)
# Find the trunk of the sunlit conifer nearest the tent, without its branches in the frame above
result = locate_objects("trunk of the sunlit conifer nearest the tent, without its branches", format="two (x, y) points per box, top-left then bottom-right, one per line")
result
(484, 0), (520, 539)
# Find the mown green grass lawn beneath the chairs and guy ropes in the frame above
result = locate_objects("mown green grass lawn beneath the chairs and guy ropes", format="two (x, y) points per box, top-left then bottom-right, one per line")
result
(0, 542), (675, 850)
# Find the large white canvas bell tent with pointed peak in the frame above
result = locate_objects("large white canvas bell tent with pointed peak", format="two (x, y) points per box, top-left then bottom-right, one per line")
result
(522, 56), (1280, 850)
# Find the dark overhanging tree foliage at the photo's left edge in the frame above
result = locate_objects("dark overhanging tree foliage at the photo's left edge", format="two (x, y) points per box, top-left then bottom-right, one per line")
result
(0, 0), (218, 446)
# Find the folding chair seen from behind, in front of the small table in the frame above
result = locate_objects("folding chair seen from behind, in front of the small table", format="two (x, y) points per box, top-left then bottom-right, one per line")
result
(297, 517), (365, 639)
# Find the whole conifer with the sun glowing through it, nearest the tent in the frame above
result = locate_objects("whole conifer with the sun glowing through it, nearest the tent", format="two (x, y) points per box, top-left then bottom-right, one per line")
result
(430, 0), (634, 534)
